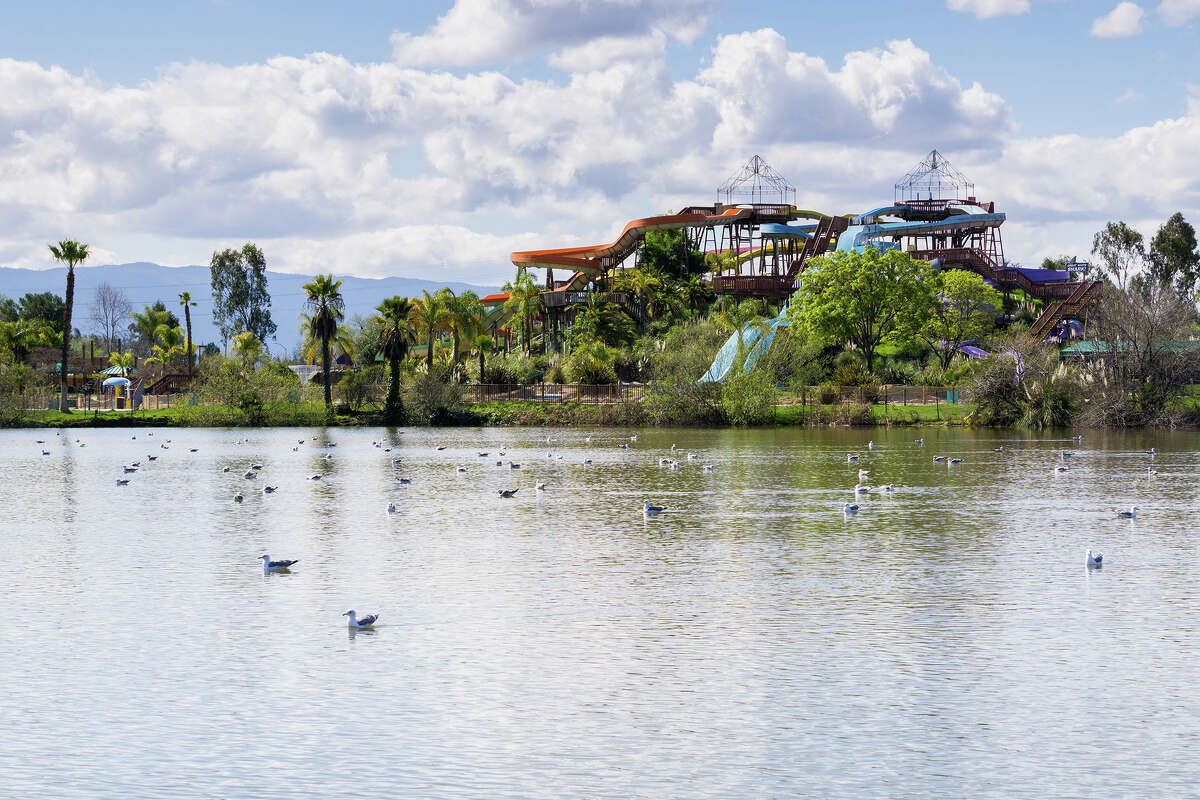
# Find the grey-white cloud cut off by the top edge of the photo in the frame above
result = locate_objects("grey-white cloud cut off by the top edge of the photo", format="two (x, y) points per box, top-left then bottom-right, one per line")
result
(391, 0), (721, 66)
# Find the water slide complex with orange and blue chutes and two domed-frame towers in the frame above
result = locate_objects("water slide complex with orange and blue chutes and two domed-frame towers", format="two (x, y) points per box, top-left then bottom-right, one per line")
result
(498, 150), (1099, 380)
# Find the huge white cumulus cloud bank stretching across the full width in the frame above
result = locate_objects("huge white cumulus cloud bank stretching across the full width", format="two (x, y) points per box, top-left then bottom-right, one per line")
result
(0, 29), (1200, 284)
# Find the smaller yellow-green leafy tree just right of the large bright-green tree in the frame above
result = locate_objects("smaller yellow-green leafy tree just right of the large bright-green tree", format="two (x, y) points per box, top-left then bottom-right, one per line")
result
(920, 270), (1001, 369)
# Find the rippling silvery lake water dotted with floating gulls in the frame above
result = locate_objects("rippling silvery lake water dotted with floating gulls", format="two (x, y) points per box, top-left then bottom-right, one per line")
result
(0, 428), (1200, 800)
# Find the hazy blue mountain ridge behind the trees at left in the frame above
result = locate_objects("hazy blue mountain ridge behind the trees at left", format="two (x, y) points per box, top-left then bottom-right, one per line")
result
(0, 261), (499, 355)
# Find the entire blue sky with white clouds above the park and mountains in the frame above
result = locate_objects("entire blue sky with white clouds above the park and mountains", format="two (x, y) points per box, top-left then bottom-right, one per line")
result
(0, 0), (1200, 284)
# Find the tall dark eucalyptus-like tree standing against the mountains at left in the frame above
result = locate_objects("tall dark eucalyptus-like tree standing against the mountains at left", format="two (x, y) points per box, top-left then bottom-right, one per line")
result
(209, 242), (277, 342)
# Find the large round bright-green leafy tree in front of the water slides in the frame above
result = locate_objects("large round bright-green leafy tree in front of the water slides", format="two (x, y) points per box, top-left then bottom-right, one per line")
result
(788, 247), (937, 369)
